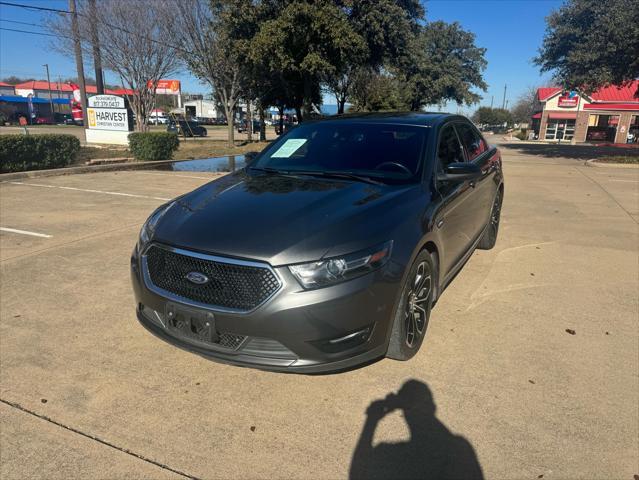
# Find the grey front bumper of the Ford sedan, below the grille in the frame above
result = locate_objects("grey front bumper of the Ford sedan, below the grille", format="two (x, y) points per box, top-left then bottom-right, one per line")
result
(131, 246), (401, 373)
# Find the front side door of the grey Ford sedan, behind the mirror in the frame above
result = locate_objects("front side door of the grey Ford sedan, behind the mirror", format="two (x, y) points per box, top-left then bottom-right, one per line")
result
(435, 123), (475, 273)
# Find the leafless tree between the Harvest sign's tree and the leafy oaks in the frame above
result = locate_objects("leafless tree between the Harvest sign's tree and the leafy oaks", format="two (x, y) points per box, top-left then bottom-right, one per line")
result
(172, 0), (244, 146)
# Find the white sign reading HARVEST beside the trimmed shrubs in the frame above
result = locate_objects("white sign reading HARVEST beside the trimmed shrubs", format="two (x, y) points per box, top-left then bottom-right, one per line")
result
(86, 95), (133, 145)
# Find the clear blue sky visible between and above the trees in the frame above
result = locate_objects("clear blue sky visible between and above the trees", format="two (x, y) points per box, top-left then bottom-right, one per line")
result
(0, 0), (562, 113)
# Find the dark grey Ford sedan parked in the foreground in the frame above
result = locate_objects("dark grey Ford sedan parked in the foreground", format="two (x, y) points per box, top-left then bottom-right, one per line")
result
(131, 113), (504, 372)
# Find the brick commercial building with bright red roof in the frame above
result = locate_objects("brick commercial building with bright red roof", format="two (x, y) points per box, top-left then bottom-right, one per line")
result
(532, 80), (639, 143)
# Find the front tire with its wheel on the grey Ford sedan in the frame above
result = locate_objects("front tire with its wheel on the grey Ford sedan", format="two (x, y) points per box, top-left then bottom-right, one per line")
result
(386, 250), (437, 360)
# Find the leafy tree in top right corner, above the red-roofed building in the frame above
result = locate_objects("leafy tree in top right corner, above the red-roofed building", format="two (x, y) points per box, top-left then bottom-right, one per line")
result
(534, 0), (639, 94)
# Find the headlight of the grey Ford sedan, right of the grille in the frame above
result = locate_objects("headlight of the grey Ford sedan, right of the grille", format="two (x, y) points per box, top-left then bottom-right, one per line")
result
(288, 240), (393, 289)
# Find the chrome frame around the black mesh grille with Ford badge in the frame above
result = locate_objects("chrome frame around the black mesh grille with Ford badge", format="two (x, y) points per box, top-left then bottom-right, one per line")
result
(140, 242), (285, 315)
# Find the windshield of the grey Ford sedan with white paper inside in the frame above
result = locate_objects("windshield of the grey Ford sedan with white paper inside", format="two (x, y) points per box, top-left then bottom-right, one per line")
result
(251, 121), (429, 181)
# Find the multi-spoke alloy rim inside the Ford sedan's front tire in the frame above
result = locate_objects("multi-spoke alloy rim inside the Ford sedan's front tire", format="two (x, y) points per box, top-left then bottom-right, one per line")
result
(404, 262), (433, 348)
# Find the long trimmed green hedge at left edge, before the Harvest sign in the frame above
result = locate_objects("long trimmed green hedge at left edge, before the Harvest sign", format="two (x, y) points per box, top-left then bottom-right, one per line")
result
(0, 134), (80, 173)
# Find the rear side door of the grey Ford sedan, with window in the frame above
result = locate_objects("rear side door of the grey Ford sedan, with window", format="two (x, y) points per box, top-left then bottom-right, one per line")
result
(455, 121), (496, 239)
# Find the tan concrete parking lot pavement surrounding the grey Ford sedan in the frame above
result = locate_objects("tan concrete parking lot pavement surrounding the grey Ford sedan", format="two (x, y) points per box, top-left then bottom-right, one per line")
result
(0, 151), (639, 479)
